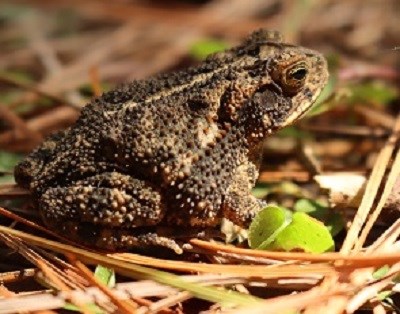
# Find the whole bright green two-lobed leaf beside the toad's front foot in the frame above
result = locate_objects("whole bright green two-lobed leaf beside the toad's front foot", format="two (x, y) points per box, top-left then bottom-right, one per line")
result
(249, 206), (335, 253)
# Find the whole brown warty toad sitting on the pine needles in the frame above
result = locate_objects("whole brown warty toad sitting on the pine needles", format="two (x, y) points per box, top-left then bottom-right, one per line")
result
(15, 30), (328, 252)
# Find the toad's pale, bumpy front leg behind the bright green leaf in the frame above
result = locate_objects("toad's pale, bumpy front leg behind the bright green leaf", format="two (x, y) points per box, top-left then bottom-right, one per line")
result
(222, 162), (266, 228)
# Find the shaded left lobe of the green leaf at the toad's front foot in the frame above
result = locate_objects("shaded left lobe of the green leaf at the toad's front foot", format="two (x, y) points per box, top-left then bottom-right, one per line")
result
(249, 206), (291, 249)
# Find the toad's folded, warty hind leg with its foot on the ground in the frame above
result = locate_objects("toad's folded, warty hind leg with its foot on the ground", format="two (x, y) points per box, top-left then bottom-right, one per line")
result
(39, 172), (179, 251)
